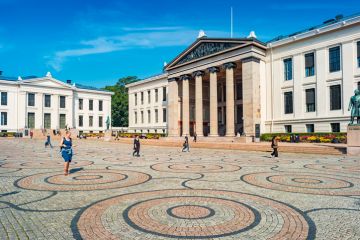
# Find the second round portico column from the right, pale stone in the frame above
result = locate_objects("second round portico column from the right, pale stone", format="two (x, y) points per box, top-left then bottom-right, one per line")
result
(209, 67), (219, 137)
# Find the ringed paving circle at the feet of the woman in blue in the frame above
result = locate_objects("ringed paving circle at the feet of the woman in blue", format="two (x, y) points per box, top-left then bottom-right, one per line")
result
(15, 170), (151, 191)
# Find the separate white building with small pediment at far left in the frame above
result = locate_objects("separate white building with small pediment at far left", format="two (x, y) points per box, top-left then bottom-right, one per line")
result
(0, 73), (113, 133)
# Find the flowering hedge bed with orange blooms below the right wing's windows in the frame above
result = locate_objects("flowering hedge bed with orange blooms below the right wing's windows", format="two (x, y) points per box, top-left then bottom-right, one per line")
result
(260, 133), (347, 143)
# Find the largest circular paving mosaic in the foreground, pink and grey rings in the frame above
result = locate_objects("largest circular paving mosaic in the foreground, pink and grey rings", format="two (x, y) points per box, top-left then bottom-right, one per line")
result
(74, 190), (313, 239)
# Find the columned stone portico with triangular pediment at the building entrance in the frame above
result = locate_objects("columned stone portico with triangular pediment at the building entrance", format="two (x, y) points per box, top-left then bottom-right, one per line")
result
(166, 37), (266, 137)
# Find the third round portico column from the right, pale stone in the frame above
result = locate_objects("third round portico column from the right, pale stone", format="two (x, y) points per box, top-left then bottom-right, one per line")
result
(194, 71), (204, 137)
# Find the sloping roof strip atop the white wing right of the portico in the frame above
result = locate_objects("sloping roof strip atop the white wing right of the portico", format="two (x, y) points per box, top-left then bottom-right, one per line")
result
(266, 13), (360, 44)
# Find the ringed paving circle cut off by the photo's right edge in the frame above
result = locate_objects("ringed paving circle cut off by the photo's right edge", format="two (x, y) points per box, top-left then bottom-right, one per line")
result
(241, 172), (360, 196)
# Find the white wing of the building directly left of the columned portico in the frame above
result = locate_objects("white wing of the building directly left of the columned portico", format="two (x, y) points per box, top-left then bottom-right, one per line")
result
(126, 74), (168, 133)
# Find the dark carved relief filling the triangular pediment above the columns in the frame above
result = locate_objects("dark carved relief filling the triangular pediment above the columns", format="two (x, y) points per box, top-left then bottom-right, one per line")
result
(177, 42), (240, 64)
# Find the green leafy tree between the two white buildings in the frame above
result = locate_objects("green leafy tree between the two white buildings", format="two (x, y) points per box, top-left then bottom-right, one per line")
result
(105, 76), (139, 127)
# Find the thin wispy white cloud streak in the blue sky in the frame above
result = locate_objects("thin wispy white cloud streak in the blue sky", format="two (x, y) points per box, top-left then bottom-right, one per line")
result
(46, 27), (228, 71)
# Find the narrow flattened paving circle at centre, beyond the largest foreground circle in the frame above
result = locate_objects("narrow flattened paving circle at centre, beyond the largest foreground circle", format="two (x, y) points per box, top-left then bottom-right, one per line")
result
(151, 162), (241, 173)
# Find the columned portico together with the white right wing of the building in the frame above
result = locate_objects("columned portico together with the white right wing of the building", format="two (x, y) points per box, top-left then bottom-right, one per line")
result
(129, 15), (360, 138)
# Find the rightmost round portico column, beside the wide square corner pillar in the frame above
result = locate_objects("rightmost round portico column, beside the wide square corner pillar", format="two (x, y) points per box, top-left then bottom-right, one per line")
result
(224, 62), (236, 137)
